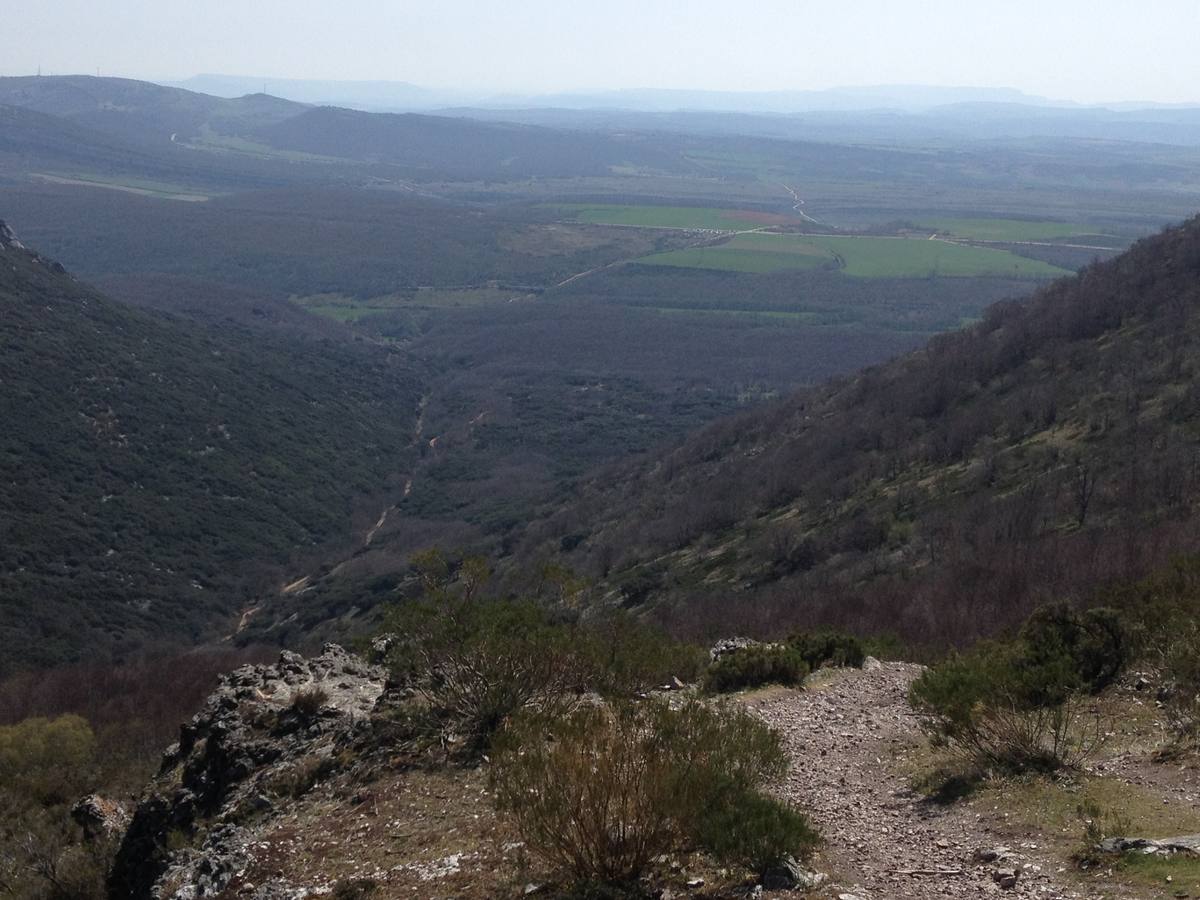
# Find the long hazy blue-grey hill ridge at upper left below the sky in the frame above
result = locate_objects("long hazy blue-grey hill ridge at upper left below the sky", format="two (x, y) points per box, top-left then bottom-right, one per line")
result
(0, 76), (696, 188)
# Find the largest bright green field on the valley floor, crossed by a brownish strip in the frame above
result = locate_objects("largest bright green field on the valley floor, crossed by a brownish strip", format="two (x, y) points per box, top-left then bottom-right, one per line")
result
(641, 234), (1070, 278)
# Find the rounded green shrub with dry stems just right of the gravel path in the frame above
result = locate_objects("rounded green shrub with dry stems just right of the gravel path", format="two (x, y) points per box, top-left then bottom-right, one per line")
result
(910, 644), (1100, 772)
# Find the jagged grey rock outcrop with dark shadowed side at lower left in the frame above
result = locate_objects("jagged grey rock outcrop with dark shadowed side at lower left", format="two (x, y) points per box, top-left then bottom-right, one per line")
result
(109, 644), (385, 900)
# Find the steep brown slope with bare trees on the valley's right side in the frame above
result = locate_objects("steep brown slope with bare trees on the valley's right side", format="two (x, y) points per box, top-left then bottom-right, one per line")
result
(522, 218), (1200, 644)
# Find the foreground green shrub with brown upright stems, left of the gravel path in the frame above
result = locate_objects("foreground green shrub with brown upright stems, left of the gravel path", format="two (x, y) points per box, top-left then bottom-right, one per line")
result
(492, 702), (812, 884)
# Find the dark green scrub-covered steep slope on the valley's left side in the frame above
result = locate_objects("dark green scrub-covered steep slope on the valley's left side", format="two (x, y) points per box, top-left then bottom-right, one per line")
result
(0, 228), (420, 673)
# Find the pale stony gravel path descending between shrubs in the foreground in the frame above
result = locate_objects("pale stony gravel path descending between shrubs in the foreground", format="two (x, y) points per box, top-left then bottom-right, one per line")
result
(751, 662), (1081, 900)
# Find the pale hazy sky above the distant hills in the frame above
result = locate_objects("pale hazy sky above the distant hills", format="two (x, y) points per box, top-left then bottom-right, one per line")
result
(7, 0), (1200, 102)
